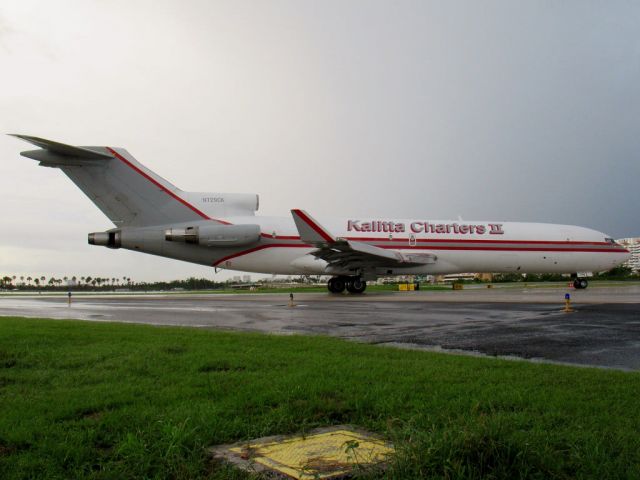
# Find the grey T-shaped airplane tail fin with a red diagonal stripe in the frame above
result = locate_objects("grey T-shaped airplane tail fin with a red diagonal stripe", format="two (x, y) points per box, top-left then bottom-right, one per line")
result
(12, 135), (215, 227)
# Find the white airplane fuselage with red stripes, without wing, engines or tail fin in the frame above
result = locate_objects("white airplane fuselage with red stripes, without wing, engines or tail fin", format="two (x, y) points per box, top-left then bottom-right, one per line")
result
(111, 216), (629, 276)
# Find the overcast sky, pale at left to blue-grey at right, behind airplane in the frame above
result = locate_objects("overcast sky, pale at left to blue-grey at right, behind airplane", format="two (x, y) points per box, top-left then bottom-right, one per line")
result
(0, 0), (640, 280)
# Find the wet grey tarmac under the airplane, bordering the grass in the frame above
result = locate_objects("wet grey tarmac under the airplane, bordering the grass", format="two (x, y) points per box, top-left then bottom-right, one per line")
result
(0, 286), (640, 370)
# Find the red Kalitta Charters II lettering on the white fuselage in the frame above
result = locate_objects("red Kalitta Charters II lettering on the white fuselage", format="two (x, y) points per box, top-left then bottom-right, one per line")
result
(347, 220), (504, 235)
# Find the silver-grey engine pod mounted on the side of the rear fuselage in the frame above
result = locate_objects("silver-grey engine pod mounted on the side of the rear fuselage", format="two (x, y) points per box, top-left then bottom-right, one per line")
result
(164, 225), (260, 247)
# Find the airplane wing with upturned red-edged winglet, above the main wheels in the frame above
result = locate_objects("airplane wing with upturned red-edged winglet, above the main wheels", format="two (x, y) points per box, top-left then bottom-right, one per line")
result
(291, 209), (437, 271)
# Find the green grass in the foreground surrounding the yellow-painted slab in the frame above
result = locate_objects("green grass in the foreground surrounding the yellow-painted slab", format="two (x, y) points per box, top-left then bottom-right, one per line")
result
(0, 318), (640, 479)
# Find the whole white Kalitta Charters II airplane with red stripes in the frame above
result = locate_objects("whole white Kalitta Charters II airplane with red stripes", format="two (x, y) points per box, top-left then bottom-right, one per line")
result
(14, 135), (629, 293)
